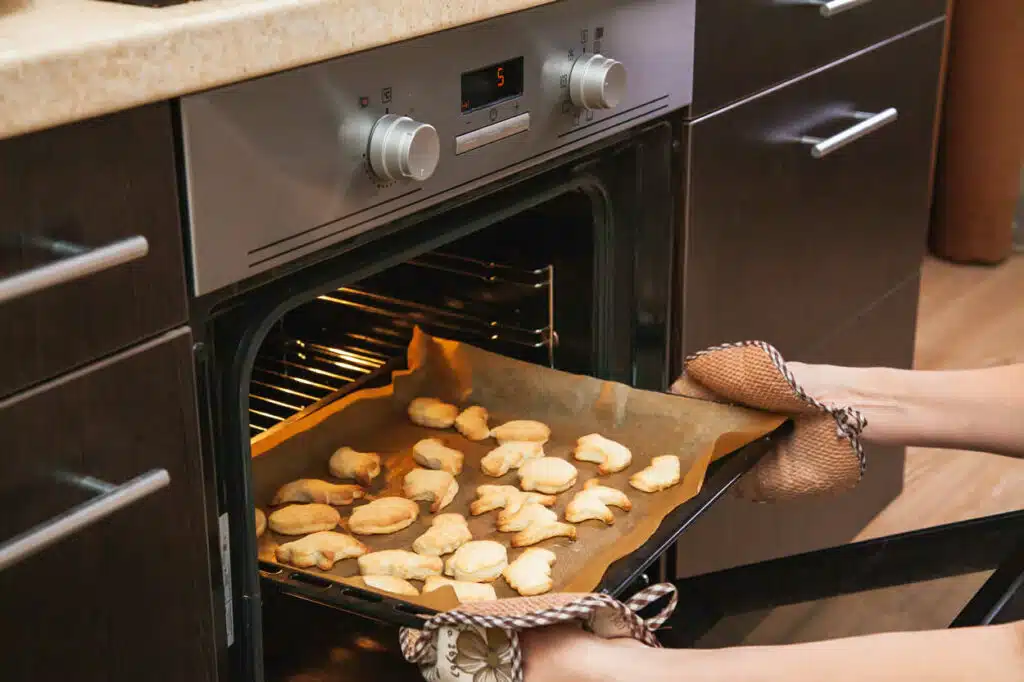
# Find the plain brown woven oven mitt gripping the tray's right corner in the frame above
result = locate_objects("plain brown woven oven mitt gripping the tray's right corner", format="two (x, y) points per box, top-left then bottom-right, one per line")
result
(672, 341), (867, 502)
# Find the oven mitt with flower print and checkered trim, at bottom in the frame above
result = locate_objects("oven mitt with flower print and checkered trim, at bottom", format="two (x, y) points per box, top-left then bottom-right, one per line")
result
(399, 583), (676, 682)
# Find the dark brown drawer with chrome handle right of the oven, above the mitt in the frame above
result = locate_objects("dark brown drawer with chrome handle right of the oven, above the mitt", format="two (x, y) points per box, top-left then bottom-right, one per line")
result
(682, 25), (943, 356)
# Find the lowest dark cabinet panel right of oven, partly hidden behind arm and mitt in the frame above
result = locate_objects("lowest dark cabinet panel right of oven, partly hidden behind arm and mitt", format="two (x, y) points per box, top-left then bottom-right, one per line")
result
(677, 276), (920, 576)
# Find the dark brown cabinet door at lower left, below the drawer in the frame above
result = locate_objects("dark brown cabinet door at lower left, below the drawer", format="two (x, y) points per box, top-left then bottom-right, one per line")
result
(0, 330), (214, 682)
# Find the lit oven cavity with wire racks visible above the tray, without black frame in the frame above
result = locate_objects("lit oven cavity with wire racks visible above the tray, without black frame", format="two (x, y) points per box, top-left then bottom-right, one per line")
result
(249, 189), (600, 437)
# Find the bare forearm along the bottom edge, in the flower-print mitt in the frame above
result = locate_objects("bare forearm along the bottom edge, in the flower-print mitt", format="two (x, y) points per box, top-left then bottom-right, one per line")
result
(523, 623), (1024, 682)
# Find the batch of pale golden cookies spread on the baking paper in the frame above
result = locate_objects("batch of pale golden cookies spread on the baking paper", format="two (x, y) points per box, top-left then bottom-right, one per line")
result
(256, 397), (681, 602)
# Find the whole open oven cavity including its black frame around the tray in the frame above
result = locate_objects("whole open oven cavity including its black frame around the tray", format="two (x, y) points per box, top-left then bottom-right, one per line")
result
(207, 120), (681, 680)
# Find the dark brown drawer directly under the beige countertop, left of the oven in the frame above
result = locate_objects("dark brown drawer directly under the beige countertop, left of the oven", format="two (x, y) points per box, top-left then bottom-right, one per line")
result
(0, 103), (186, 396)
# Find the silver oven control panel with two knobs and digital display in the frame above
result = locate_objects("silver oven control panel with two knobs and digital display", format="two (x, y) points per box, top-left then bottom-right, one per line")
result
(181, 0), (696, 296)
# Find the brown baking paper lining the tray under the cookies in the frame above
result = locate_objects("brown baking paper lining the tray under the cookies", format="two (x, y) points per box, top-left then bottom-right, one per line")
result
(252, 330), (784, 610)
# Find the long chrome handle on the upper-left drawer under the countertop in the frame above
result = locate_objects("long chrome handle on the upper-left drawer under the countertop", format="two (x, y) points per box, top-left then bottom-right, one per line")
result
(0, 237), (150, 303)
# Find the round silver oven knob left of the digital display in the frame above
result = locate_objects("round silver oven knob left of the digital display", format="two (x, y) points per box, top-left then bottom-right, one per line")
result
(367, 114), (441, 182)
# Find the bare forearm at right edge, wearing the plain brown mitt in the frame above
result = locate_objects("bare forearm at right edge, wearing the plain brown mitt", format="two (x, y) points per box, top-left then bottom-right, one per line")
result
(788, 363), (1024, 457)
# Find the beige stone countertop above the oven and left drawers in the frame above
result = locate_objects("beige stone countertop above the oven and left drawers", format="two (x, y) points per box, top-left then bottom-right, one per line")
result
(0, 0), (552, 138)
